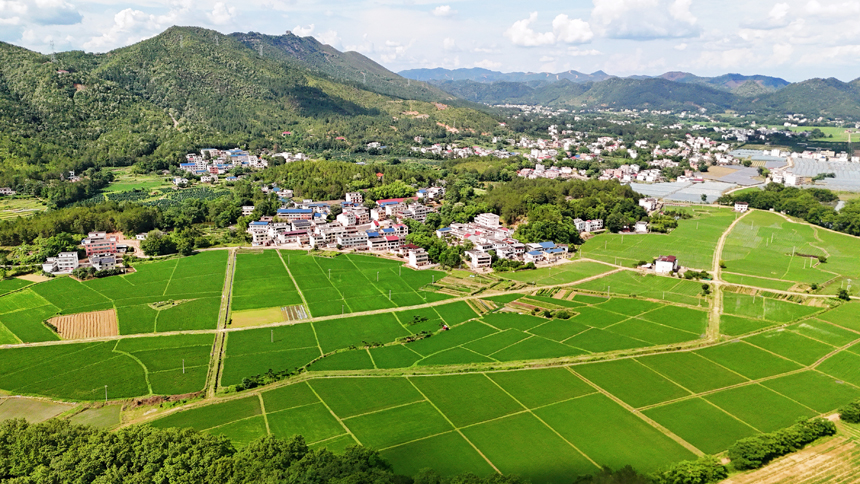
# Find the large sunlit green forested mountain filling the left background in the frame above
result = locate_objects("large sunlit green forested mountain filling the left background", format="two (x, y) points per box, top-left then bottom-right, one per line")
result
(0, 27), (498, 186)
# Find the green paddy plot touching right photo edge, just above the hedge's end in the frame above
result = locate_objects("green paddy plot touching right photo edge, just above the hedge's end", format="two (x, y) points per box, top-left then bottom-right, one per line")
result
(762, 371), (860, 413)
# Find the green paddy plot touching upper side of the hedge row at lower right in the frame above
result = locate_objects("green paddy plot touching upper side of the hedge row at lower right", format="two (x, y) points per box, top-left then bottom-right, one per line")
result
(705, 385), (815, 432)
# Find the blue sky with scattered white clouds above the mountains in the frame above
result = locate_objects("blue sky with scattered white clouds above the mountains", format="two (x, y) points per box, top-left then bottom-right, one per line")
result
(0, 0), (860, 81)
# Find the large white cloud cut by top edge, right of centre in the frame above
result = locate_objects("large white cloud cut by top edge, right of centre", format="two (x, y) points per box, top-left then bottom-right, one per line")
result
(590, 0), (700, 40)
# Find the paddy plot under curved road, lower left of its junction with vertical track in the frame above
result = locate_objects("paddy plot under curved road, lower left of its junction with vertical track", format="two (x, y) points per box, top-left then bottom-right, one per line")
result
(637, 352), (747, 393)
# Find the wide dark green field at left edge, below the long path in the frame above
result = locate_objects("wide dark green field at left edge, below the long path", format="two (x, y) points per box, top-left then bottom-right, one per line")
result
(0, 335), (214, 400)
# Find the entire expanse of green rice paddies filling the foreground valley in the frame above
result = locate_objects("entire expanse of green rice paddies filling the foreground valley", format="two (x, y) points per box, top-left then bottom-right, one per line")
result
(5, 211), (860, 484)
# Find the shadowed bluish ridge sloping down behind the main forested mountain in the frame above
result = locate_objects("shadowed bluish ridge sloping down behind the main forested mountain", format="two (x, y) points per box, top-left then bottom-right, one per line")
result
(230, 32), (454, 102)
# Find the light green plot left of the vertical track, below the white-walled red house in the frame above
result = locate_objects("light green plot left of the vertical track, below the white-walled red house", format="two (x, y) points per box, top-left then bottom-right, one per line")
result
(576, 271), (708, 306)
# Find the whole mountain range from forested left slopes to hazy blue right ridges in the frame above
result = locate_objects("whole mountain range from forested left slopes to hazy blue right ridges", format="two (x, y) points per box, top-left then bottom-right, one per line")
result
(0, 27), (860, 186)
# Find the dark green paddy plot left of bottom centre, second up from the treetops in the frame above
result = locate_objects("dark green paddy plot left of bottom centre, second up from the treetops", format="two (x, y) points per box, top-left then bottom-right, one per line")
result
(344, 402), (453, 450)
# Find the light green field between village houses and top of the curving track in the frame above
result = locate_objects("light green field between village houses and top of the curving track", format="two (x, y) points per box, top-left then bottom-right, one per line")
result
(580, 207), (736, 270)
